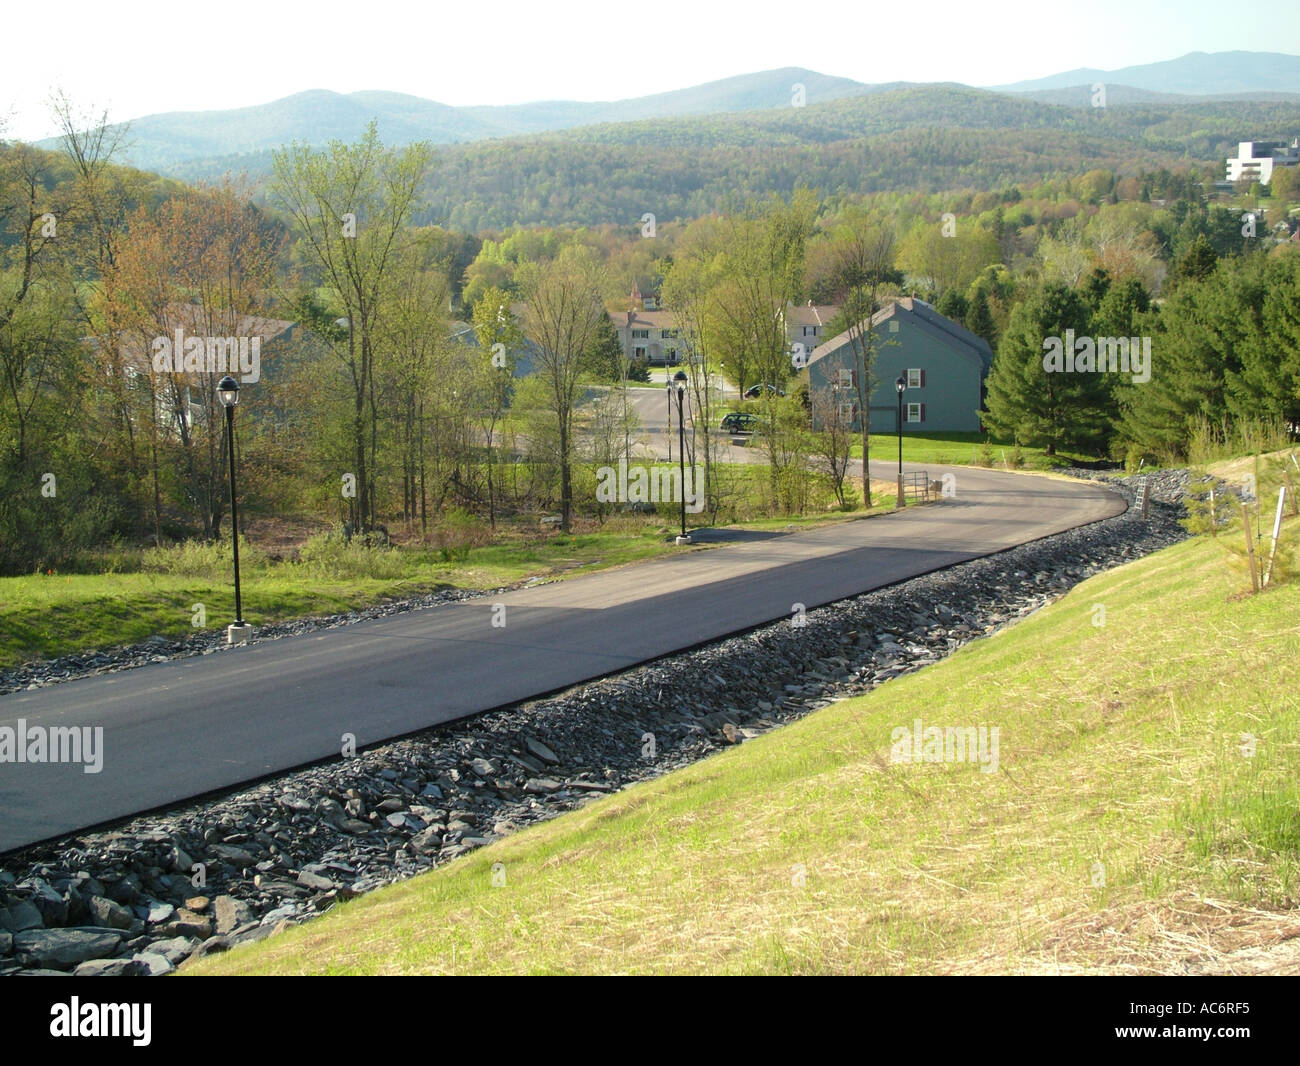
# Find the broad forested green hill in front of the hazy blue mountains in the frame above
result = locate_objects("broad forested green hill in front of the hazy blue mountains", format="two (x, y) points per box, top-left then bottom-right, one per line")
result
(144, 86), (1300, 230)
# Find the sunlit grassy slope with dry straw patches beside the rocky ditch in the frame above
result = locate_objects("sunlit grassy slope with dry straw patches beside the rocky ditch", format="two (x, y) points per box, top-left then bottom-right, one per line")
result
(189, 521), (1300, 974)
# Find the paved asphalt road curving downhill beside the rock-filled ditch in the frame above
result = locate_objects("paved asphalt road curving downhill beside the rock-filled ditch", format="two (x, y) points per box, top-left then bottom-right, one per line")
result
(0, 464), (1125, 852)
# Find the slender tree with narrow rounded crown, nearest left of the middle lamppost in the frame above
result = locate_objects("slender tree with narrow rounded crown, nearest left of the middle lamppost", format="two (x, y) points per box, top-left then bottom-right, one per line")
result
(516, 244), (606, 533)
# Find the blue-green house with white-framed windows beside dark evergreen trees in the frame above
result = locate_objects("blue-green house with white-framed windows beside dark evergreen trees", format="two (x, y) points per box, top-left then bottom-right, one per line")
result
(805, 296), (993, 433)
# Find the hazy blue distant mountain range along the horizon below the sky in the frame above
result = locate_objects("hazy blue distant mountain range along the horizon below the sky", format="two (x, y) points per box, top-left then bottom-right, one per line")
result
(35, 52), (1300, 178)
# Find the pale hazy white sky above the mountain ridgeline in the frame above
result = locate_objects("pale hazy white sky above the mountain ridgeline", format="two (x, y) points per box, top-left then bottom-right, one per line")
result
(0, 0), (1300, 139)
